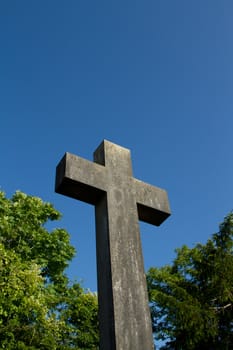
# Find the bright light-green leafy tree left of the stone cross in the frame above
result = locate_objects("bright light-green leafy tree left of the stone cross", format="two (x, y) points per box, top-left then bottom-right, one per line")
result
(0, 192), (98, 350)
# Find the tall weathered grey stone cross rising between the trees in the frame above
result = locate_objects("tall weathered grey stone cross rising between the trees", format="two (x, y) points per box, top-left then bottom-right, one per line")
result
(56, 140), (170, 350)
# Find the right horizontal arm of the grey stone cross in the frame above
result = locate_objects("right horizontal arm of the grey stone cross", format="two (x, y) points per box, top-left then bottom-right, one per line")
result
(133, 179), (171, 226)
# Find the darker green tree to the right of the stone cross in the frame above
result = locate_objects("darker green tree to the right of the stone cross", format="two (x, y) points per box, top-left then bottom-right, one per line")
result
(147, 213), (233, 350)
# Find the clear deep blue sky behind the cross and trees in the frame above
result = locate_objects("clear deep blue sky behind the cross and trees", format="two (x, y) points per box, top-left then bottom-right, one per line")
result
(0, 0), (233, 296)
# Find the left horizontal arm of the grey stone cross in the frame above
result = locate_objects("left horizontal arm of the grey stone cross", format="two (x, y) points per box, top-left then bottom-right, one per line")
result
(55, 153), (106, 205)
